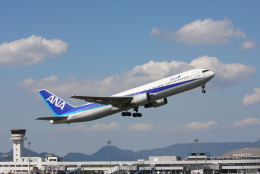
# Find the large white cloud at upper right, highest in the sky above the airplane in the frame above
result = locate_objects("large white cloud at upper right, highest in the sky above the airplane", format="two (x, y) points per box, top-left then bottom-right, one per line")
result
(150, 19), (246, 45)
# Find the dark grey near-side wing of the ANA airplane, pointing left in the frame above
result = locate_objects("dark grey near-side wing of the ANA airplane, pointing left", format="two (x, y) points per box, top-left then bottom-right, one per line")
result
(70, 95), (133, 105)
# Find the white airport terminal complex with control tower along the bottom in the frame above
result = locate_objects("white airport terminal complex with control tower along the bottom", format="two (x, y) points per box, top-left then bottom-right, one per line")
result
(0, 129), (260, 174)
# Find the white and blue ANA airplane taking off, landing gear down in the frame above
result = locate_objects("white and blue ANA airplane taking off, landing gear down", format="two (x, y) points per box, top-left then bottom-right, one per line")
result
(36, 69), (215, 124)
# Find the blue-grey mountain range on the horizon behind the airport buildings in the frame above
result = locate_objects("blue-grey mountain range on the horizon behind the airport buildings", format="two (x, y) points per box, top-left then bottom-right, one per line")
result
(0, 140), (260, 161)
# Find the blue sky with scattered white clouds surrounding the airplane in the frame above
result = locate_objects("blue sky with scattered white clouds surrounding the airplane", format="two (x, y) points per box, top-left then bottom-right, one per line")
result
(0, 1), (260, 155)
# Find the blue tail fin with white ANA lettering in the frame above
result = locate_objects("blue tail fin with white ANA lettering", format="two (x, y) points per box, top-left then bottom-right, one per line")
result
(39, 89), (75, 116)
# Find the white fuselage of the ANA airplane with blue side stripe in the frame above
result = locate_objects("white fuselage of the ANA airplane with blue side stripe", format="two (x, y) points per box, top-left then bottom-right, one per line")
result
(50, 69), (214, 124)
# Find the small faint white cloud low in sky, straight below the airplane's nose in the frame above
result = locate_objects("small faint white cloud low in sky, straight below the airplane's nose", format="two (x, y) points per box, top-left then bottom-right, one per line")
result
(184, 121), (218, 131)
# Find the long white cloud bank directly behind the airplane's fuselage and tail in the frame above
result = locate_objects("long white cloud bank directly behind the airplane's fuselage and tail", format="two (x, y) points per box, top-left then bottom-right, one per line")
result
(19, 56), (256, 97)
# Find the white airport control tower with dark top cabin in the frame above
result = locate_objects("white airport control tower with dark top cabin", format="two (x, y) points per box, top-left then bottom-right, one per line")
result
(10, 129), (27, 162)
